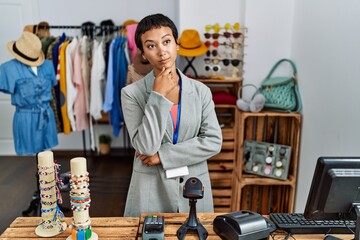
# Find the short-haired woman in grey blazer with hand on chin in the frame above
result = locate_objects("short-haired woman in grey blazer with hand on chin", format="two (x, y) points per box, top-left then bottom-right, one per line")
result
(121, 14), (222, 217)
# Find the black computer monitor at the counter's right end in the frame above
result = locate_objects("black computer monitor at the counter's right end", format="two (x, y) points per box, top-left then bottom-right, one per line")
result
(304, 157), (360, 239)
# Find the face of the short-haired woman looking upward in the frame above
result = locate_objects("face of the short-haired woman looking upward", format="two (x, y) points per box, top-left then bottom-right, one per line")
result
(141, 27), (178, 76)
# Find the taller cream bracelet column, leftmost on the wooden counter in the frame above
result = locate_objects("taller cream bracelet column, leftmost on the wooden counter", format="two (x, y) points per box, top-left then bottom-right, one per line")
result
(35, 151), (67, 237)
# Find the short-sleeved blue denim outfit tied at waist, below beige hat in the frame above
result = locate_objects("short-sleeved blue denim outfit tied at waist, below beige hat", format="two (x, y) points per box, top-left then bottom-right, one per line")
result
(0, 59), (58, 155)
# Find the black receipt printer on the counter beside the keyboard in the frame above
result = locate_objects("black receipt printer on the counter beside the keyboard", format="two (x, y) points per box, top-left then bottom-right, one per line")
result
(213, 211), (271, 240)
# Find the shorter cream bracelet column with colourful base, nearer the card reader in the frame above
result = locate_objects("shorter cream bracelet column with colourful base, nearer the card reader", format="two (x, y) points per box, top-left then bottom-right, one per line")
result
(67, 157), (98, 240)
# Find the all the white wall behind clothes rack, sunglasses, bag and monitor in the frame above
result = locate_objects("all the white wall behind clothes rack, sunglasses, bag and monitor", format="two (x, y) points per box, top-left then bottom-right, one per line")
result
(0, 0), (360, 212)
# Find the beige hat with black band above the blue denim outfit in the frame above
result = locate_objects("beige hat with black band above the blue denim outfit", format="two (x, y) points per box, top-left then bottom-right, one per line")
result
(7, 32), (45, 67)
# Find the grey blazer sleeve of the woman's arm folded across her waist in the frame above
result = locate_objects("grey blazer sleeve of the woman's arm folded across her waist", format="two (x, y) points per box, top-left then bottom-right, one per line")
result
(159, 88), (222, 170)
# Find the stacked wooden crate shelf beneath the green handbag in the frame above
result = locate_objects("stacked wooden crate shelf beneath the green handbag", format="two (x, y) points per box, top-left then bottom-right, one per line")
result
(231, 112), (301, 214)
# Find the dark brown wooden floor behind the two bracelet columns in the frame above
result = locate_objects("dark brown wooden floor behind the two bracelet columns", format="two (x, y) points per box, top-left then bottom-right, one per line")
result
(0, 150), (133, 234)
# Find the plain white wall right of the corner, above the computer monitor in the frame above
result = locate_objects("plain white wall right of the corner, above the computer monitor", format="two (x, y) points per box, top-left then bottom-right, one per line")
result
(291, 0), (360, 211)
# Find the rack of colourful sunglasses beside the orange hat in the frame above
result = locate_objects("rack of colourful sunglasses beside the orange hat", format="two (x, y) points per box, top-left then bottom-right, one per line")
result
(204, 23), (246, 80)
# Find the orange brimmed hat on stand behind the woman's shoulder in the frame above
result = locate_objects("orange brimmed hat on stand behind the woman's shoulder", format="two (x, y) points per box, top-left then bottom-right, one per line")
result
(178, 29), (208, 57)
